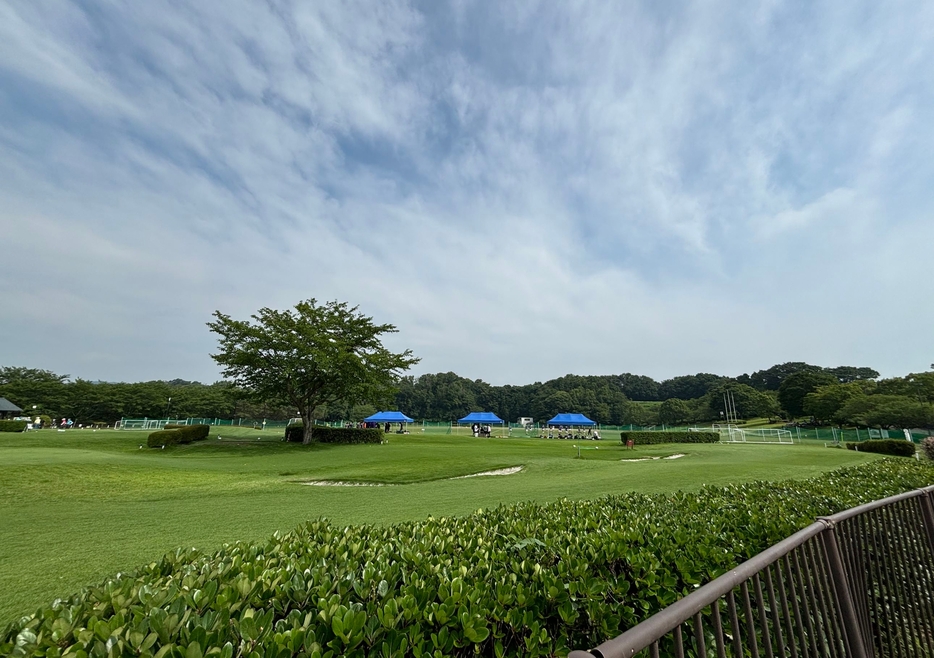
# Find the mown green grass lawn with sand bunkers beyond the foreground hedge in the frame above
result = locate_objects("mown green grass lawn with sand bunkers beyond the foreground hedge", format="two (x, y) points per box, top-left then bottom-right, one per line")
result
(0, 427), (875, 624)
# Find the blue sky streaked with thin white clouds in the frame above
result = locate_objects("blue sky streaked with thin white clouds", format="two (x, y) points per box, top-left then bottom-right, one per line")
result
(0, 0), (934, 384)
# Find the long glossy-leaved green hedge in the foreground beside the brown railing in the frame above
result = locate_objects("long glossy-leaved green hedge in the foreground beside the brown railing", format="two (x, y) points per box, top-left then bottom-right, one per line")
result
(0, 459), (934, 658)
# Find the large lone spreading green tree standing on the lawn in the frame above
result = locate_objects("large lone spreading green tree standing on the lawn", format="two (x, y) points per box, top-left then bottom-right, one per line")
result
(207, 299), (418, 443)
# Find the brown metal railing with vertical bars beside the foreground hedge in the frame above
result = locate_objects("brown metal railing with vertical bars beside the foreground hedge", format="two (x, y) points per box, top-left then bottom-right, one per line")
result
(569, 486), (934, 658)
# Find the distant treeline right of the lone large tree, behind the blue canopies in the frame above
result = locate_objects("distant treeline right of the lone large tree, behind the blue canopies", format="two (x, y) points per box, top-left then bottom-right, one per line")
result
(325, 362), (934, 427)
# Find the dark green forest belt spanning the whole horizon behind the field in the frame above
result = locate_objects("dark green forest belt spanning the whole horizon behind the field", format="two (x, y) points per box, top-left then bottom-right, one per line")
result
(0, 362), (934, 427)
